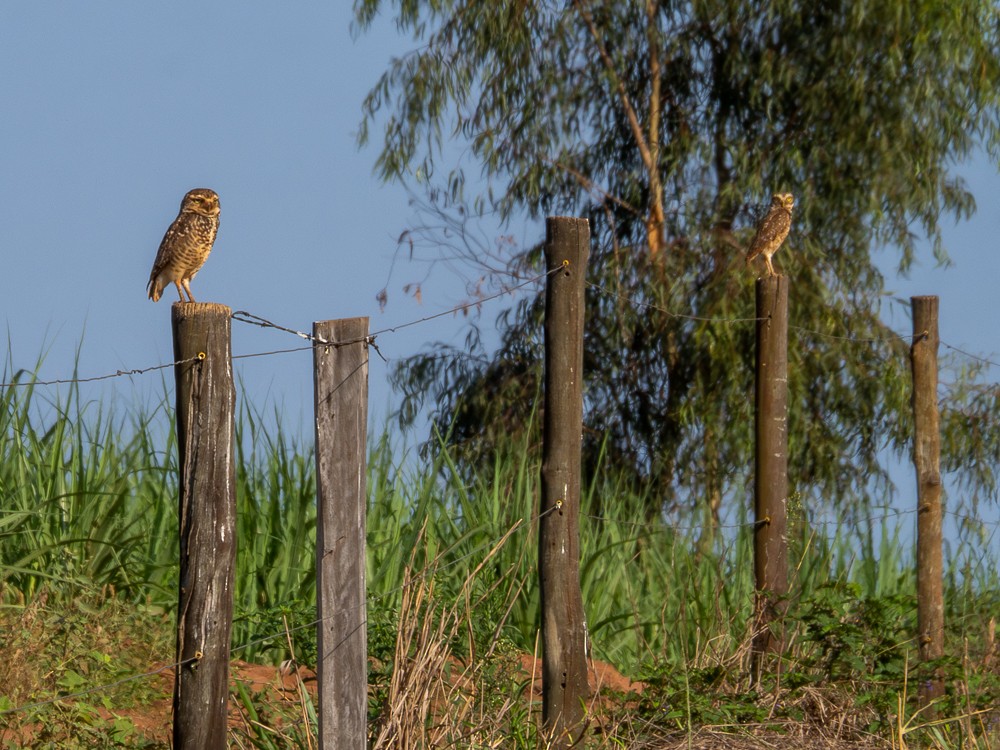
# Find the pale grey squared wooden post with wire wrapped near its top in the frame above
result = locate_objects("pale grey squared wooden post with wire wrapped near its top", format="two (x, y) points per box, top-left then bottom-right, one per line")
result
(313, 318), (368, 750)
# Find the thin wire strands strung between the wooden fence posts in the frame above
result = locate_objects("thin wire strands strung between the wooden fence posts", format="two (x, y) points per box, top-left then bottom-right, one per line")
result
(0, 269), (1000, 717)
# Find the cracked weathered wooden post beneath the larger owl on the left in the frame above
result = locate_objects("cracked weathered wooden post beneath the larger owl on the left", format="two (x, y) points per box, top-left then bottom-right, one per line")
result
(171, 302), (236, 750)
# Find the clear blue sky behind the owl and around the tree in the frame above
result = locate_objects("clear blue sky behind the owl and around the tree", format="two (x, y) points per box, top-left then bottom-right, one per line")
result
(0, 0), (1000, 524)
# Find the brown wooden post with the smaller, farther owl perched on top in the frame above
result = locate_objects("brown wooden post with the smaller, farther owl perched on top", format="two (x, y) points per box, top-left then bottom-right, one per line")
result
(751, 276), (788, 683)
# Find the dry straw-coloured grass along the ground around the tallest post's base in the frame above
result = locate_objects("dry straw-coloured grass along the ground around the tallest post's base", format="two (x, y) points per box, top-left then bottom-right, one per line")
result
(360, 534), (994, 750)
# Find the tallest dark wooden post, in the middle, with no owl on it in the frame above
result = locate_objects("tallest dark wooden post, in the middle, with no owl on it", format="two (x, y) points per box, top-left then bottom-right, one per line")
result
(538, 217), (590, 748)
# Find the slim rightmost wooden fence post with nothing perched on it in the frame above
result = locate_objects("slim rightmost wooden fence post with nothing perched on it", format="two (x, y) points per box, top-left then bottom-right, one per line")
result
(910, 297), (944, 706)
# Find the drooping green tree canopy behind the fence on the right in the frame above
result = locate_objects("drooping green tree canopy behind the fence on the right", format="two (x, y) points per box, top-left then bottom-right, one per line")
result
(355, 0), (1000, 528)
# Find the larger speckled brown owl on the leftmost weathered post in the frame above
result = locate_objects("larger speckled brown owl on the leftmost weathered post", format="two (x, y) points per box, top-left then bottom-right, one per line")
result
(146, 188), (219, 302)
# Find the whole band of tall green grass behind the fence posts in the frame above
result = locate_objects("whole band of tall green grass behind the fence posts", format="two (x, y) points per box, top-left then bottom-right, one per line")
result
(0, 373), (1000, 692)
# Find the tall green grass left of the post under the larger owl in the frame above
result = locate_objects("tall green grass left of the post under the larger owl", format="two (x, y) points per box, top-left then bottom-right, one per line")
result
(0, 373), (176, 602)
